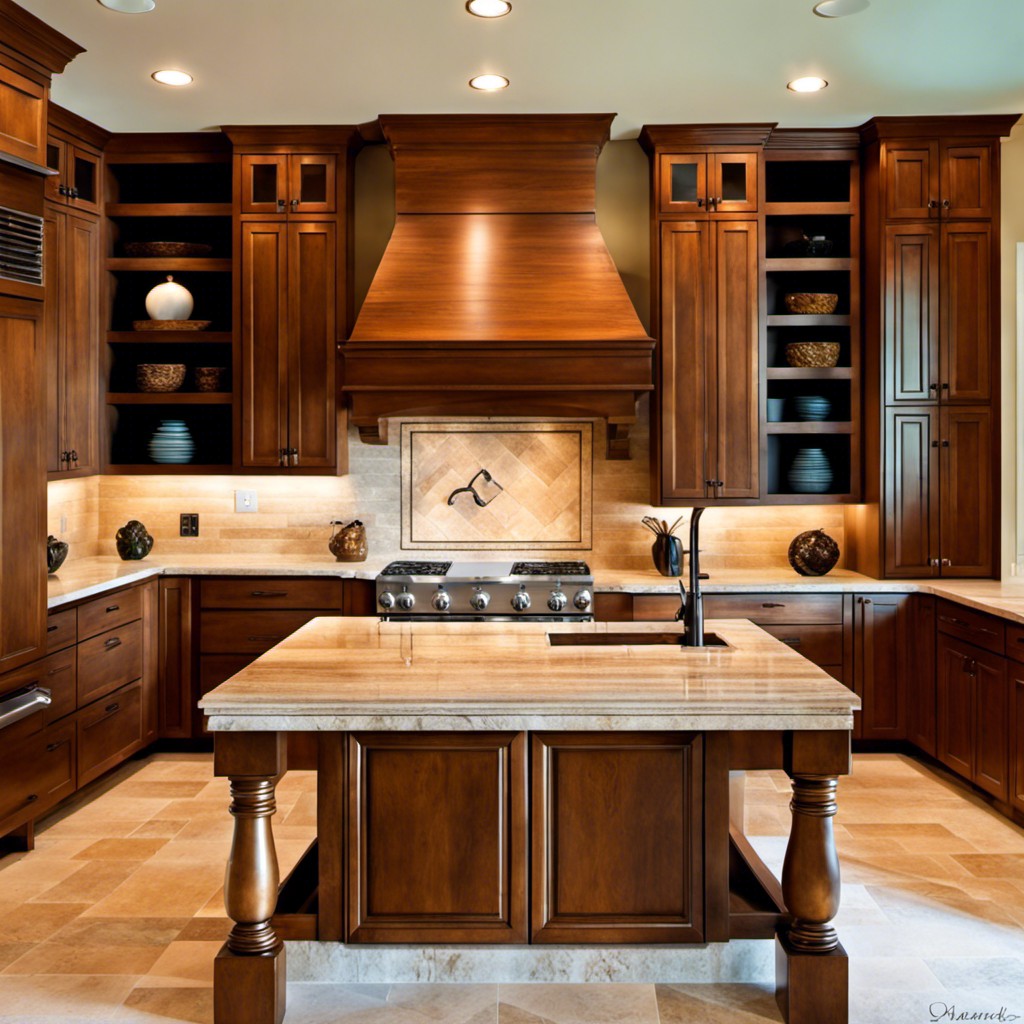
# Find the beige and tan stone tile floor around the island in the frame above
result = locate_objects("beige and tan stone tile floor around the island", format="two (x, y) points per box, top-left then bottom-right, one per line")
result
(0, 755), (1024, 1024)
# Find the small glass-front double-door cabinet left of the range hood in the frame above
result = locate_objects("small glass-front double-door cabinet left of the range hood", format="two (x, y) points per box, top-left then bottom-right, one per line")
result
(239, 153), (338, 214)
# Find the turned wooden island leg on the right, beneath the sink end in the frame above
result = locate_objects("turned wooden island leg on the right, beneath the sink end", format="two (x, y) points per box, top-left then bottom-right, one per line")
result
(775, 733), (849, 1024)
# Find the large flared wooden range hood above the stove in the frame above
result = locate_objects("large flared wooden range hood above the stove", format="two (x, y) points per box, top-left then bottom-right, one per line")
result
(341, 114), (654, 459)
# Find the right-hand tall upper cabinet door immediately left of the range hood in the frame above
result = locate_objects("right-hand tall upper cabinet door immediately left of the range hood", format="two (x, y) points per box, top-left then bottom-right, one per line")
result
(288, 222), (338, 468)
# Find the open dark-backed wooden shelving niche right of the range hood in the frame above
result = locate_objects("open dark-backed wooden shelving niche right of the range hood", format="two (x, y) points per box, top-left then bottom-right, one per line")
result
(761, 136), (861, 505)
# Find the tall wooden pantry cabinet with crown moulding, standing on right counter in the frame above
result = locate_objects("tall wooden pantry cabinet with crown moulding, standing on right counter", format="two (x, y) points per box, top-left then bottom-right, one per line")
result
(849, 115), (1017, 578)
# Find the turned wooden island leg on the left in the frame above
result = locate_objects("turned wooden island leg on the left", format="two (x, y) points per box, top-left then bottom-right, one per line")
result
(213, 732), (287, 1024)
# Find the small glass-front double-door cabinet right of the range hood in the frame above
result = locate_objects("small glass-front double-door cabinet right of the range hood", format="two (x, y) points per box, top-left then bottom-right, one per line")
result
(657, 153), (758, 216)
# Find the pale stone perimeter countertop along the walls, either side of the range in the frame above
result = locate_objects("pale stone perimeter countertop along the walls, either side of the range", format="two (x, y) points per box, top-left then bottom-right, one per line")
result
(47, 554), (1024, 625)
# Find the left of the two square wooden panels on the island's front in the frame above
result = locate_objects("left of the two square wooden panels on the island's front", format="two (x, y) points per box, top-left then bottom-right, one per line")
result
(346, 732), (527, 943)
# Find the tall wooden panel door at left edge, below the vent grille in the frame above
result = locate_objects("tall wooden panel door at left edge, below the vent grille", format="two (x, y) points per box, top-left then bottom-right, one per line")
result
(0, 298), (46, 672)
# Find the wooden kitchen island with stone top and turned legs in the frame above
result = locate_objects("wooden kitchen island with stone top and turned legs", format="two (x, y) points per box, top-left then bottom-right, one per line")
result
(203, 618), (860, 1024)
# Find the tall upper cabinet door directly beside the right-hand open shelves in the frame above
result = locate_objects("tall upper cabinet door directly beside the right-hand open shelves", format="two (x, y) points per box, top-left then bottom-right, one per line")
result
(708, 220), (759, 498)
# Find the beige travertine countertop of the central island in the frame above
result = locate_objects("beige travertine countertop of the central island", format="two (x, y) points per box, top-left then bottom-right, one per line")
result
(200, 617), (860, 731)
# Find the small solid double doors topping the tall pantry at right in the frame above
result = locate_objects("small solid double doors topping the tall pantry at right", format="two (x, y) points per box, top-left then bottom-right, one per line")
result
(882, 138), (996, 220)
